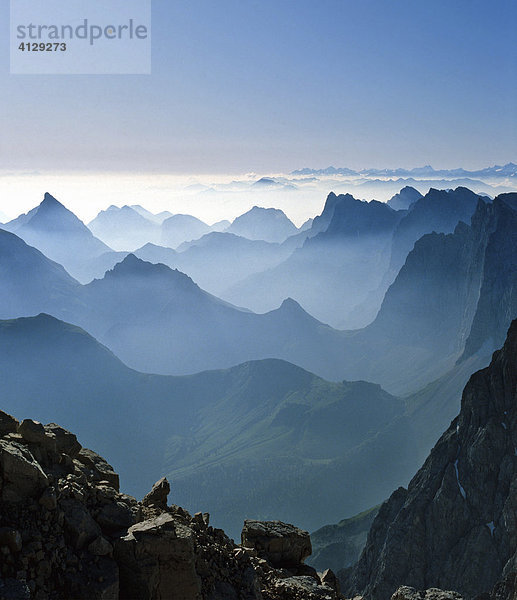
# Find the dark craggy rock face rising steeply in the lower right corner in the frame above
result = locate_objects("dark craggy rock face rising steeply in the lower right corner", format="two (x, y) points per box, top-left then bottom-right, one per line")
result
(341, 321), (517, 600)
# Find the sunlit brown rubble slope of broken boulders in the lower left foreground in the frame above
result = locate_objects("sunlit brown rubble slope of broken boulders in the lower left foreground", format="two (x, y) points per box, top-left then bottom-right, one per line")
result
(0, 411), (342, 600)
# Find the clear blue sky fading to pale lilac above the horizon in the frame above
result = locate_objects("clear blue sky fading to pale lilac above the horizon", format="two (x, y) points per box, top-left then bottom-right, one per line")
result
(0, 0), (517, 173)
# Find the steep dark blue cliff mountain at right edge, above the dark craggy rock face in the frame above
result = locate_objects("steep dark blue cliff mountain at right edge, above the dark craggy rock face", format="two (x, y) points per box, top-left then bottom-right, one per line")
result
(332, 195), (517, 393)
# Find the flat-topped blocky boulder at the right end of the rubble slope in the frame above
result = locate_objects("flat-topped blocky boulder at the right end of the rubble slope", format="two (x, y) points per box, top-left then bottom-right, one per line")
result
(241, 520), (312, 568)
